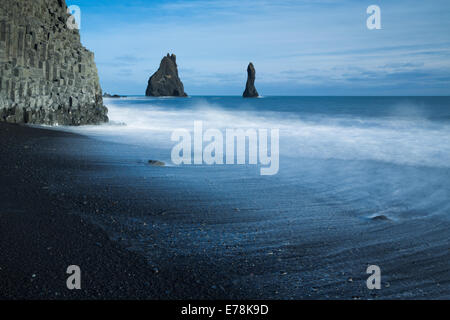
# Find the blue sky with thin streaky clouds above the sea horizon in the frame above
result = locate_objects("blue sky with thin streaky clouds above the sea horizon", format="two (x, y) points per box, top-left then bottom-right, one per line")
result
(66, 0), (450, 96)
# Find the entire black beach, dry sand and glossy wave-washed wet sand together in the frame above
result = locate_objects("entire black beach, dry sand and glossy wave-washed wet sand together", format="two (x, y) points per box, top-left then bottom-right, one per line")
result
(0, 123), (450, 299)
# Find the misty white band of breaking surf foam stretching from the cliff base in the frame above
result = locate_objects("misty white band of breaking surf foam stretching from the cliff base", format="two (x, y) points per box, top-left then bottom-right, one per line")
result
(62, 98), (450, 167)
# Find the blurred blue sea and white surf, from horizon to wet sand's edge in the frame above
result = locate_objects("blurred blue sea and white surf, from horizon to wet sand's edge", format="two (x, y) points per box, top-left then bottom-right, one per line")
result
(61, 97), (450, 218)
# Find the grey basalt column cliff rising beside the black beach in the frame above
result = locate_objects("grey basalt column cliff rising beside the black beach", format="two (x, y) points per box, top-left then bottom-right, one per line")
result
(0, 0), (108, 125)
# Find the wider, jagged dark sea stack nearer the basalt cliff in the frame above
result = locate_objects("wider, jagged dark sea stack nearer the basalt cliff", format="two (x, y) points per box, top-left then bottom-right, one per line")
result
(145, 54), (187, 97)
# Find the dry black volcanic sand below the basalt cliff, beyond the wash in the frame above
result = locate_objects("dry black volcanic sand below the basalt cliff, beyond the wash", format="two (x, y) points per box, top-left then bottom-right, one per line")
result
(0, 123), (217, 299)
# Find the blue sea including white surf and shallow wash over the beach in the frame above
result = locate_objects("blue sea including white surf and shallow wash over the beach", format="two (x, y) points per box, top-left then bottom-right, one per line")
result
(58, 96), (450, 298)
